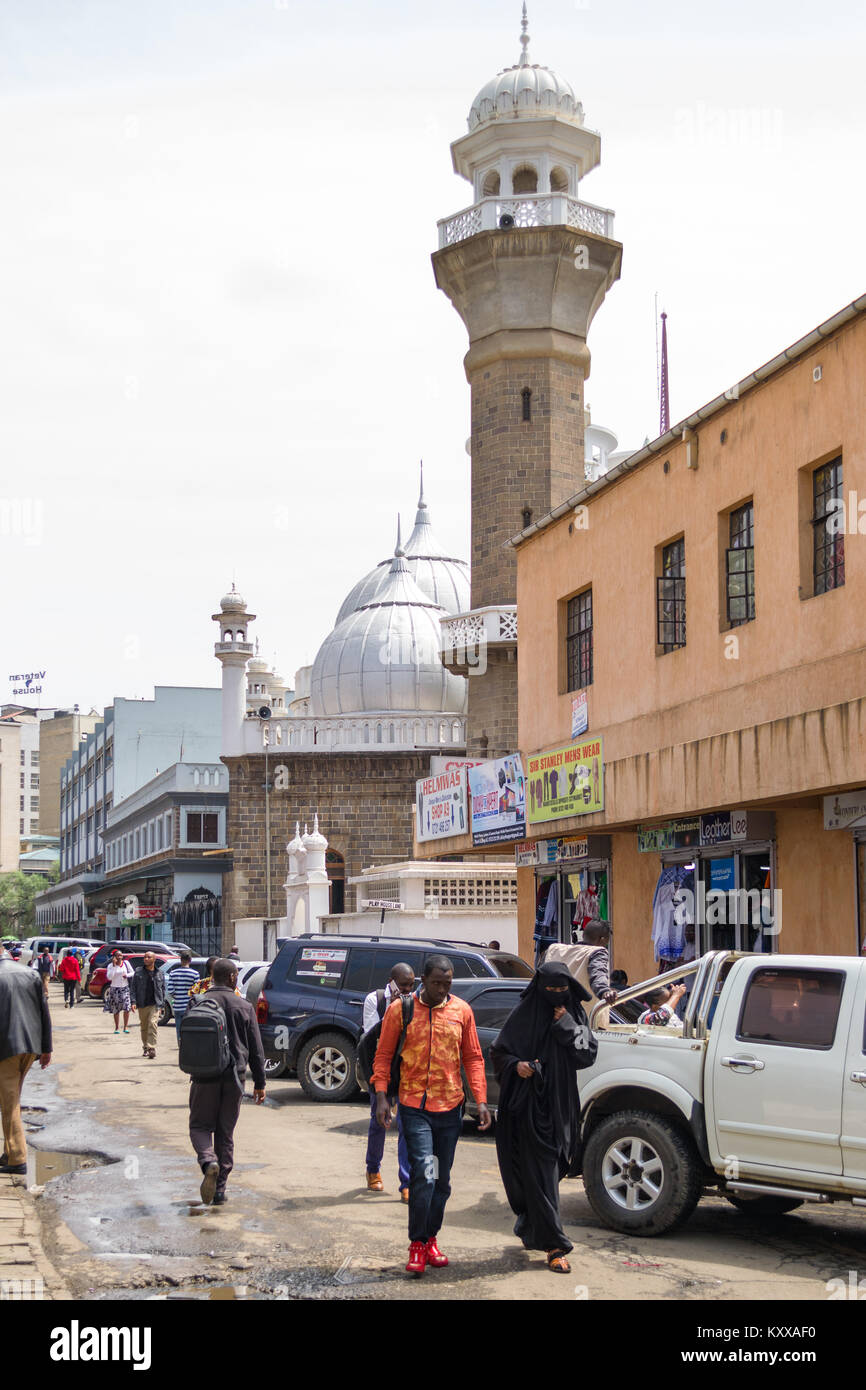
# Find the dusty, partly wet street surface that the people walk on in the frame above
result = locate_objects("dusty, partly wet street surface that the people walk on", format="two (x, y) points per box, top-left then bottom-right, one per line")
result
(24, 991), (866, 1302)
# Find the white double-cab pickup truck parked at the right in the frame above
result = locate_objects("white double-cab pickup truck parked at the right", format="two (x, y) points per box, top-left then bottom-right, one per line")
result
(571, 951), (866, 1236)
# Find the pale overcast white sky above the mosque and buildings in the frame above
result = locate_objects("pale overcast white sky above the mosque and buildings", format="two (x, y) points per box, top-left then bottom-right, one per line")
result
(0, 0), (866, 709)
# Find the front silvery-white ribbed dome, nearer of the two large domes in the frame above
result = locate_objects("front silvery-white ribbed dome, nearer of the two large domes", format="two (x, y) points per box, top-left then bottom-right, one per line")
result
(310, 548), (467, 719)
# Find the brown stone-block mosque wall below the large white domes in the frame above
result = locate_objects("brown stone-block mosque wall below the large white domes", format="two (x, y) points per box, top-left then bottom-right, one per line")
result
(222, 753), (430, 949)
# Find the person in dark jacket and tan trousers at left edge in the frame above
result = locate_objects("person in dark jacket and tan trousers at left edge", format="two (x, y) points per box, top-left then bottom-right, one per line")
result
(0, 945), (51, 1173)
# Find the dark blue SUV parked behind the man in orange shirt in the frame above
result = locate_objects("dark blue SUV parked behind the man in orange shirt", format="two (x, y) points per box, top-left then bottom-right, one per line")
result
(256, 935), (534, 1101)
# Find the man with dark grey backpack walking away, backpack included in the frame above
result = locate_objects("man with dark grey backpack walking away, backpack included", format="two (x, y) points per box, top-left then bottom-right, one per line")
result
(178, 960), (264, 1207)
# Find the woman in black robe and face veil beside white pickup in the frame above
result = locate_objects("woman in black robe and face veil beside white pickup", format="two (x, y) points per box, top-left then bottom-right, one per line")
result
(491, 962), (598, 1275)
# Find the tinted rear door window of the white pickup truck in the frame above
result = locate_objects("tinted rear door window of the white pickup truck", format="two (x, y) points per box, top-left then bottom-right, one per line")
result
(737, 969), (845, 1049)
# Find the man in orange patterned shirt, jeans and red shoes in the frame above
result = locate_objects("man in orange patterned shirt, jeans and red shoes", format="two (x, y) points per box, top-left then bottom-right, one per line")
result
(373, 955), (491, 1275)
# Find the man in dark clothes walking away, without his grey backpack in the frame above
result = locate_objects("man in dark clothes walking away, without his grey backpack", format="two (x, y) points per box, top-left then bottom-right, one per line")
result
(189, 959), (264, 1207)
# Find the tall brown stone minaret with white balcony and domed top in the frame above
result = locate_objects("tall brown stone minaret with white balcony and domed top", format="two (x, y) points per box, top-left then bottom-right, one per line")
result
(432, 6), (623, 756)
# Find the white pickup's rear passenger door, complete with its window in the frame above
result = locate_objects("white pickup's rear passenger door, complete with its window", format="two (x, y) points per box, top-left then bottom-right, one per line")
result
(708, 956), (858, 1176)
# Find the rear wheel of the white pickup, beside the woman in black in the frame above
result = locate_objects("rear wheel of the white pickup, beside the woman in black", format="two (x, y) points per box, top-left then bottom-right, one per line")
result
(584, 1111), (703, 1236)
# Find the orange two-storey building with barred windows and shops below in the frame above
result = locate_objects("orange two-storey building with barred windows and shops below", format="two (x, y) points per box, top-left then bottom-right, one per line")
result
(512, 296), (866, 981)
